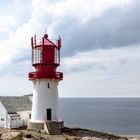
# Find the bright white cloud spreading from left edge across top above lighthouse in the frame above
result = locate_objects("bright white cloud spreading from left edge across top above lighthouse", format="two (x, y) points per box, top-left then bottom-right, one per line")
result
(0, 0), (130, 64)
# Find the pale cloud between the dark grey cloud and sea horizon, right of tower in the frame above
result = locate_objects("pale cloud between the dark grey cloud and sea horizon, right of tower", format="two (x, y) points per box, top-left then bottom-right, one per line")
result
(60, 46), (140, 97)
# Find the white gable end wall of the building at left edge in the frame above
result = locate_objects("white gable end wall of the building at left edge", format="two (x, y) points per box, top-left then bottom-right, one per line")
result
(0, 102), (7, 128)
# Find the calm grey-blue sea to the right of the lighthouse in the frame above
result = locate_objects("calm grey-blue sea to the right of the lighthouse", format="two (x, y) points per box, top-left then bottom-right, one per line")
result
(59, 98), (140, 135)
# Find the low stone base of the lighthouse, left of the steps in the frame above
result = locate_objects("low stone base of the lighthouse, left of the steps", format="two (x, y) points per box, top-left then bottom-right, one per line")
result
(28, 122), (44, 130)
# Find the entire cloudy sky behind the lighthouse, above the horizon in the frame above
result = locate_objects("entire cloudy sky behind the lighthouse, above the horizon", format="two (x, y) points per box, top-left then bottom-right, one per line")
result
(0, 0), (140, 97)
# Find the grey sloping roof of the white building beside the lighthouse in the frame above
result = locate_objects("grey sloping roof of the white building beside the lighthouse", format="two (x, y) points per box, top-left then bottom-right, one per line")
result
(0, 96), (32, 113)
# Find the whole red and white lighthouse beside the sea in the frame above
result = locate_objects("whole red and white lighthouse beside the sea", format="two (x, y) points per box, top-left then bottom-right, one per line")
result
(28, 34), (63, 131)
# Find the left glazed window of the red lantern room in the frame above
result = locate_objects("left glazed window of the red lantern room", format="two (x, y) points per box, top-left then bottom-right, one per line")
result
(33, 48), (42, 63)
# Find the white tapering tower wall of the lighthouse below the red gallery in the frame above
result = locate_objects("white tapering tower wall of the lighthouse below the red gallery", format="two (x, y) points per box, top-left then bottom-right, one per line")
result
(30, 79), (59, 122)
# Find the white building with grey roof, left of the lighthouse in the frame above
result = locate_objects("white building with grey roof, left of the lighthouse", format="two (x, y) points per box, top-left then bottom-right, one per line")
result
(0, 95), (32, 128)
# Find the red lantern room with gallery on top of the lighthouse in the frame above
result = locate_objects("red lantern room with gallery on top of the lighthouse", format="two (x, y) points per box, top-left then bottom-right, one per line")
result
(29, 34), (63, 80)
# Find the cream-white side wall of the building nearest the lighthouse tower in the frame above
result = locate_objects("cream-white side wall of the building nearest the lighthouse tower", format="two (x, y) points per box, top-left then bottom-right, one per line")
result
(17, 110), (31, 126)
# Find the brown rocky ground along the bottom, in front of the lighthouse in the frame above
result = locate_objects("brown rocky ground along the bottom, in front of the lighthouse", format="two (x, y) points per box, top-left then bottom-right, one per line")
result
(0, 127), (140, 140)
